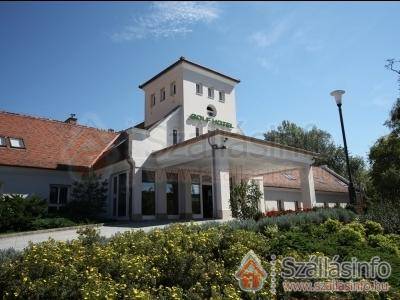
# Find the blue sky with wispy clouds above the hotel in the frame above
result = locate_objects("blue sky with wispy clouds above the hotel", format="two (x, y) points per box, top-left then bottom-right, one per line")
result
(0, 2), (400, 156)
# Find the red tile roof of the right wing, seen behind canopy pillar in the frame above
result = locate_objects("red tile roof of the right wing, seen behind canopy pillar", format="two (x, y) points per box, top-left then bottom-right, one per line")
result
(264, 167), (348, 193)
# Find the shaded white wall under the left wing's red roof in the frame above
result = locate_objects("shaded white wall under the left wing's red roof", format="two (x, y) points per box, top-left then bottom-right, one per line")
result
(0, 166), (80, 199)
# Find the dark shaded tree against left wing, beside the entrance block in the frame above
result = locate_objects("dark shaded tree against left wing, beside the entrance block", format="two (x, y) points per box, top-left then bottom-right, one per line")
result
(66, 172), (108, 219)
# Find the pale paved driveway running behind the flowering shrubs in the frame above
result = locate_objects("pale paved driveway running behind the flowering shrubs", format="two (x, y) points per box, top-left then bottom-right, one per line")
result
(0, 221), (220, 250)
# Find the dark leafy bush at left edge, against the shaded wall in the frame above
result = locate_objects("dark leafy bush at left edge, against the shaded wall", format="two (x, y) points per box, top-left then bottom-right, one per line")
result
(0, 195), (47, 232)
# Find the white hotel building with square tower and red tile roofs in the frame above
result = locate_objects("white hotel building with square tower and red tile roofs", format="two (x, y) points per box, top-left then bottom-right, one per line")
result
(0, 57), (348, 220)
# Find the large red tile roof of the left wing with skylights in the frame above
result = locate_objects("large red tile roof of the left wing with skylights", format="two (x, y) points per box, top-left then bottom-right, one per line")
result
(0, 111), (119, 169)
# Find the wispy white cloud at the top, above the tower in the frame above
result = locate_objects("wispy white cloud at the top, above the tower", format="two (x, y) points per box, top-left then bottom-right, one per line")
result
(112, 1), (220, 41)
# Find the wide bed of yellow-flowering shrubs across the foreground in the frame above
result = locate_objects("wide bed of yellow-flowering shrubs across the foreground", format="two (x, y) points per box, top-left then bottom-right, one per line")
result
(0, 220), (400, 299)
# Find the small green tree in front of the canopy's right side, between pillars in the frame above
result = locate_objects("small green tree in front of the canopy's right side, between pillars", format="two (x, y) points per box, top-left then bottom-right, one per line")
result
(229, 180), (262, 220)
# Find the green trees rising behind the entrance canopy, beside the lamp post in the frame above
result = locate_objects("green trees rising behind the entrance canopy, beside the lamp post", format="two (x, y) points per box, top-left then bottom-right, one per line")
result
(264, 121), (368, 187)
